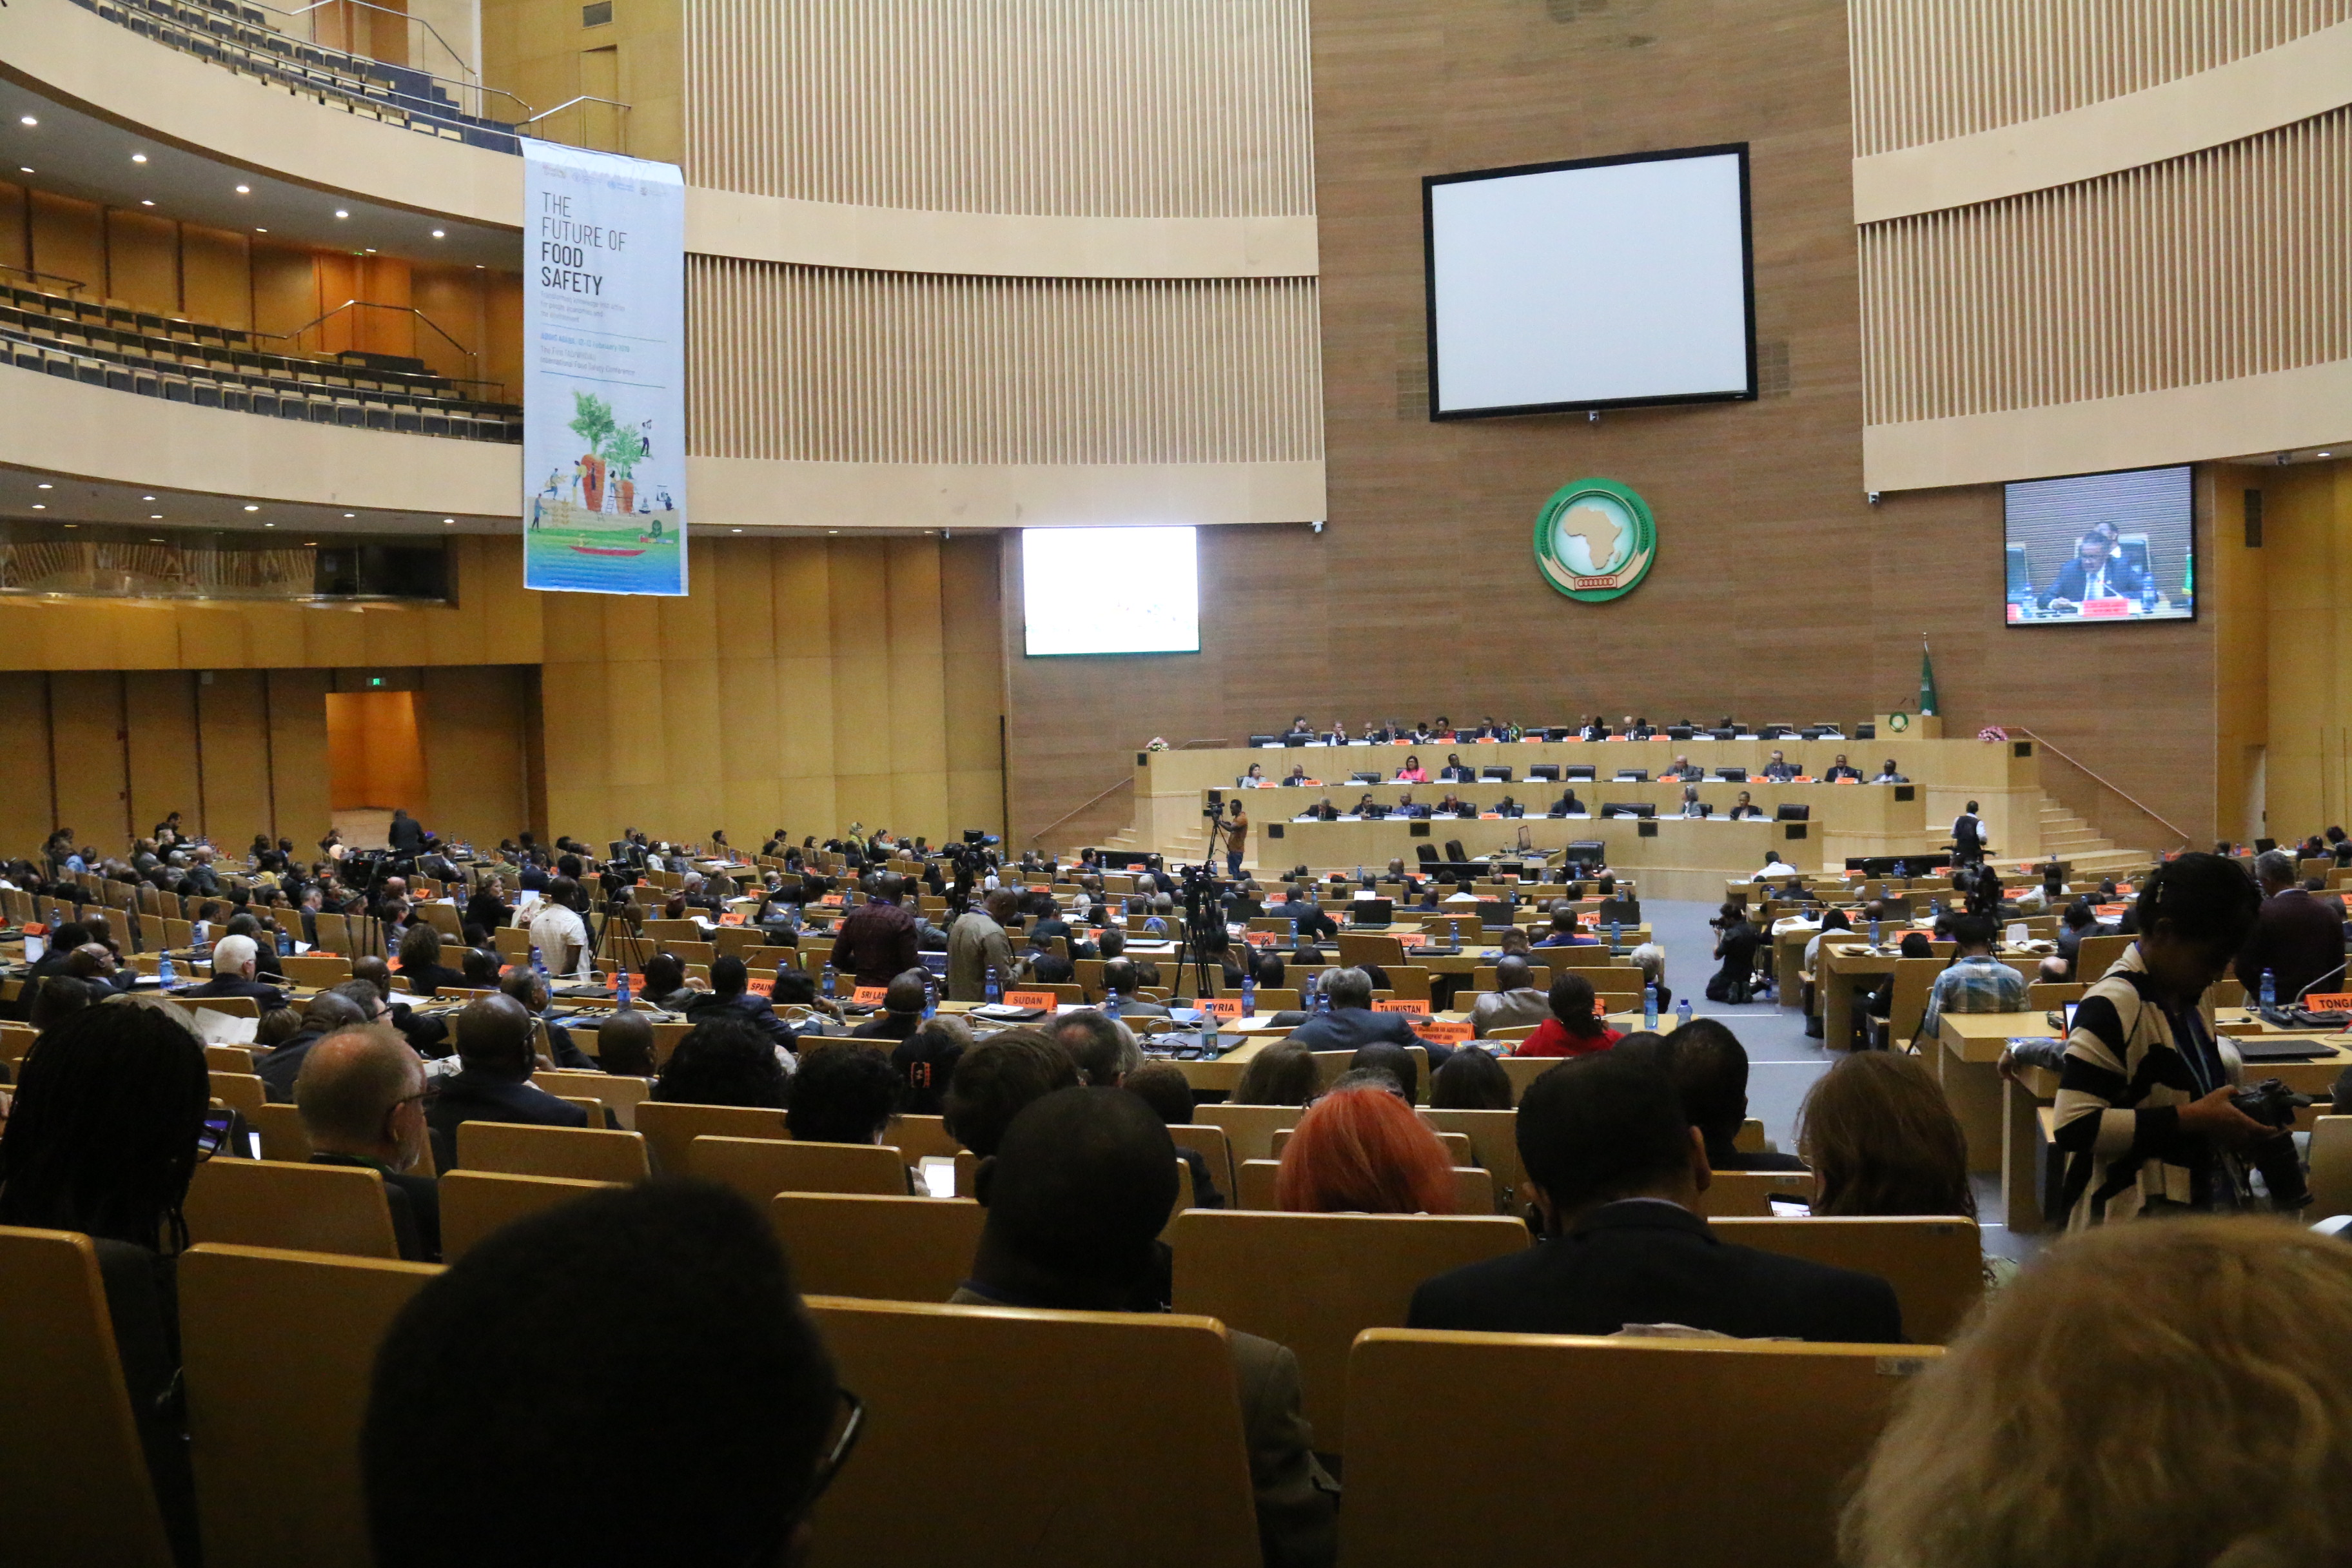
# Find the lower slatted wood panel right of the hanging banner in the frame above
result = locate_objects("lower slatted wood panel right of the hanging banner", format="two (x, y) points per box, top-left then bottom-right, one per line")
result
(687, 256), (1322, 463)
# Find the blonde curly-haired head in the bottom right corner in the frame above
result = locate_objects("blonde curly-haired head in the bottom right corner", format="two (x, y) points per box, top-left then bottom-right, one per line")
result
(1839, 1222), (2352, 1568)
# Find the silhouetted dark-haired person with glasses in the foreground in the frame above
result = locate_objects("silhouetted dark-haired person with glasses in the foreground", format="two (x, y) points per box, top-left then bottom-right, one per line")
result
(360, 1182), (859, 1568)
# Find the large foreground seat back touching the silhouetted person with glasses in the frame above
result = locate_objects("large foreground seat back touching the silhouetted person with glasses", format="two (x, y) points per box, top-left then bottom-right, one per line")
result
(807, 1295), (1260, 1568)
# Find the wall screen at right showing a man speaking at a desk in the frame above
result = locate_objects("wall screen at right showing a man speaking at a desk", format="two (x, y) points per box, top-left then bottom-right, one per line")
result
(2001, 468), (2197, 625)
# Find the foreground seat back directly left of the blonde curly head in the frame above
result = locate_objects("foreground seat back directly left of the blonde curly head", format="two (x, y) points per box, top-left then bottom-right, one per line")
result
(1340, 1328), (1943, 1568)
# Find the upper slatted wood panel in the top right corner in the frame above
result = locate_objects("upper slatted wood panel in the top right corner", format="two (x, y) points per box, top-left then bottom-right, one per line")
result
(1848, 0), (2352, 157)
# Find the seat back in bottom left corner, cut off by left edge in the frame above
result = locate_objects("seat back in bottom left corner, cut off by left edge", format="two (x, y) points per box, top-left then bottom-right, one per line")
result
(0, 1225), (172, 1568)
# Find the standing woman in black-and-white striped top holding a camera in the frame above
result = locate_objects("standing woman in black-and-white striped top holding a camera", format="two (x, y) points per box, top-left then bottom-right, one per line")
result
(2001, 854), (2308, 1230)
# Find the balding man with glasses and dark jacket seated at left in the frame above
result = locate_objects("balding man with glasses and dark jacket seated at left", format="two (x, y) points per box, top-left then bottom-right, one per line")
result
(294, 1025), (440, 1262)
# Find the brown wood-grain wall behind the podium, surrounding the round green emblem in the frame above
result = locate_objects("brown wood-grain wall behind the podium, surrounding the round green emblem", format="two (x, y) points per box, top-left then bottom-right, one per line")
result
(1004, 0), (2215, 847)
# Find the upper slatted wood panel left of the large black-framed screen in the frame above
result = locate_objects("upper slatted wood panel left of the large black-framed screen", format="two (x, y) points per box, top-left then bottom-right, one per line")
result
(687, 0), (1315, 216)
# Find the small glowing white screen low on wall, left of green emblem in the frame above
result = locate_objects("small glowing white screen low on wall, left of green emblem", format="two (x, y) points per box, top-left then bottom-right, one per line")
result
(1021, 529), (1199, 656)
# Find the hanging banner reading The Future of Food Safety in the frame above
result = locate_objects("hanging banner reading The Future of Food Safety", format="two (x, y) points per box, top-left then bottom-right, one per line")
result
(522, 139), (687, 594)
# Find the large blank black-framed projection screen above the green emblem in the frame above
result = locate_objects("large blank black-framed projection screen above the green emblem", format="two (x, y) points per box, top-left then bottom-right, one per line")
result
(1420, 146), (1754, 418)
